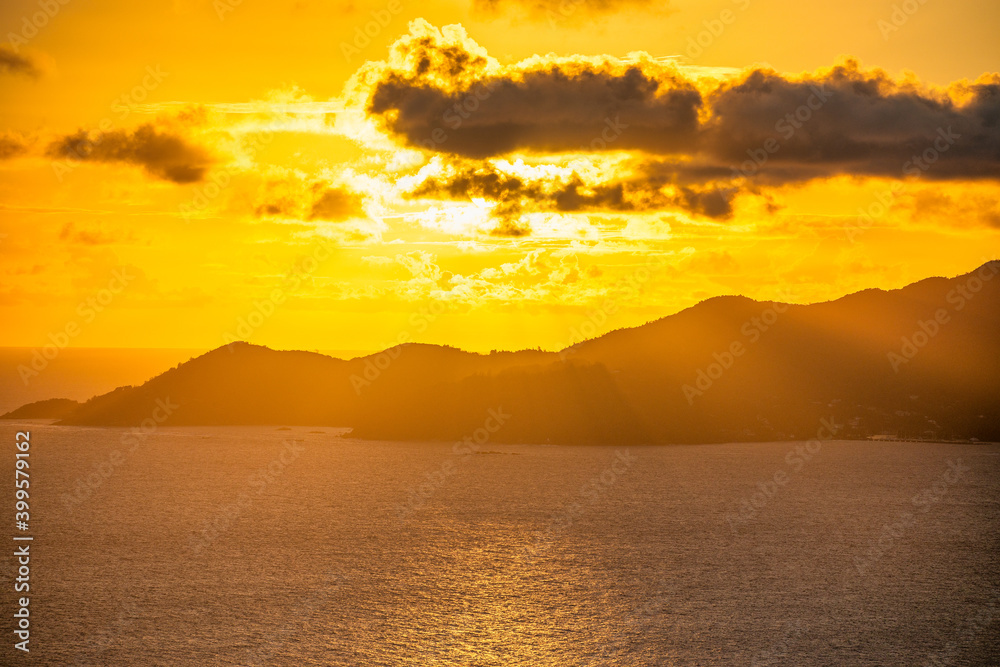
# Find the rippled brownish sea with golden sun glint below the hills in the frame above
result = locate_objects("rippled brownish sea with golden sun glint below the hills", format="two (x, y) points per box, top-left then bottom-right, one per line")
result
(0, 423), (1000, 667)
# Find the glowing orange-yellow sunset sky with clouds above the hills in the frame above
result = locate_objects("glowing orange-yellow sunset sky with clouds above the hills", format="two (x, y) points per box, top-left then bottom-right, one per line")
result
(0, 0), (1000, 351)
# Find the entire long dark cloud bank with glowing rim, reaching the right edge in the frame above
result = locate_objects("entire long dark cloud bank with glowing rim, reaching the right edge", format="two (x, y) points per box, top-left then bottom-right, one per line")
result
(355, 21), (1000, 184)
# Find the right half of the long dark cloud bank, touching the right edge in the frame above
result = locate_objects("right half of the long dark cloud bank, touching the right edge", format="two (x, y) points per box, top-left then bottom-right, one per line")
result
(698, 61), (1000, 182)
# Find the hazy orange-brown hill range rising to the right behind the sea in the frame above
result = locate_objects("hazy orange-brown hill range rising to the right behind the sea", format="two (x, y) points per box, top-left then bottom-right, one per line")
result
(27, 262), (1000, 443)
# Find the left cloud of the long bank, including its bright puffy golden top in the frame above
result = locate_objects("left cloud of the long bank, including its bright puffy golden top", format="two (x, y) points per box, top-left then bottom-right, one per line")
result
(367, 21), (702, 158)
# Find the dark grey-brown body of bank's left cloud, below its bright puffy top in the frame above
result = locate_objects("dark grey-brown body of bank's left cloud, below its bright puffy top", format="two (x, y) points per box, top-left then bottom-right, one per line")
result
(368, 65), (702, 157)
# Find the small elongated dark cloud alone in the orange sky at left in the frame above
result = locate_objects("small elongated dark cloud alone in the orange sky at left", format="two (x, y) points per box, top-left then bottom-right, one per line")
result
(48, 123), (214, 183)
